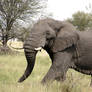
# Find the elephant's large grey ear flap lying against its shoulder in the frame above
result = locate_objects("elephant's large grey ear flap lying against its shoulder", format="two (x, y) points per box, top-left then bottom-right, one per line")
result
(52, 31), (79, 53)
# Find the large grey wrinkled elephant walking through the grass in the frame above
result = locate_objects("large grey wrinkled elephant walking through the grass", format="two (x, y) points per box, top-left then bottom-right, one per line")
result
(19, 19), (92, 84)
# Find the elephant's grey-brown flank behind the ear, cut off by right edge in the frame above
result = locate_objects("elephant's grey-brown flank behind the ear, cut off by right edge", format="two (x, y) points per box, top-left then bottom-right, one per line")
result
(77, 31), (92, 70)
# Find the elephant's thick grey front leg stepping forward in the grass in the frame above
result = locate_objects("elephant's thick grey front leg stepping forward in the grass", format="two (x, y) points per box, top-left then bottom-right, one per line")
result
(42, 52), (72, 84)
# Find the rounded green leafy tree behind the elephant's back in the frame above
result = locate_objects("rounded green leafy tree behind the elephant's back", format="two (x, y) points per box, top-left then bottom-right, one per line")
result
(68, 11), (92, 31)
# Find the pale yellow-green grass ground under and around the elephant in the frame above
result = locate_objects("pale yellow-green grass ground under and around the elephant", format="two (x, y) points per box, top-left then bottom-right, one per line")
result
(0, 41), (92, 92)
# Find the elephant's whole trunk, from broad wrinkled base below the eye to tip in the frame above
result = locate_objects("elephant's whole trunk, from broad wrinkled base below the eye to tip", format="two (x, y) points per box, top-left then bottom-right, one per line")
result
(19, 33), (45, 82)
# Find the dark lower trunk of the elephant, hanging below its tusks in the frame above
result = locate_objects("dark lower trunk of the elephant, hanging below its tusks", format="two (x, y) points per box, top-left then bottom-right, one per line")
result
(18, 51), (36, 82)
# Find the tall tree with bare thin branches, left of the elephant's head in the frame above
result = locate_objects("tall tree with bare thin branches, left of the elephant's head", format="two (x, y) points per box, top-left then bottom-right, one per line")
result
(0, 0), (46, 47)
